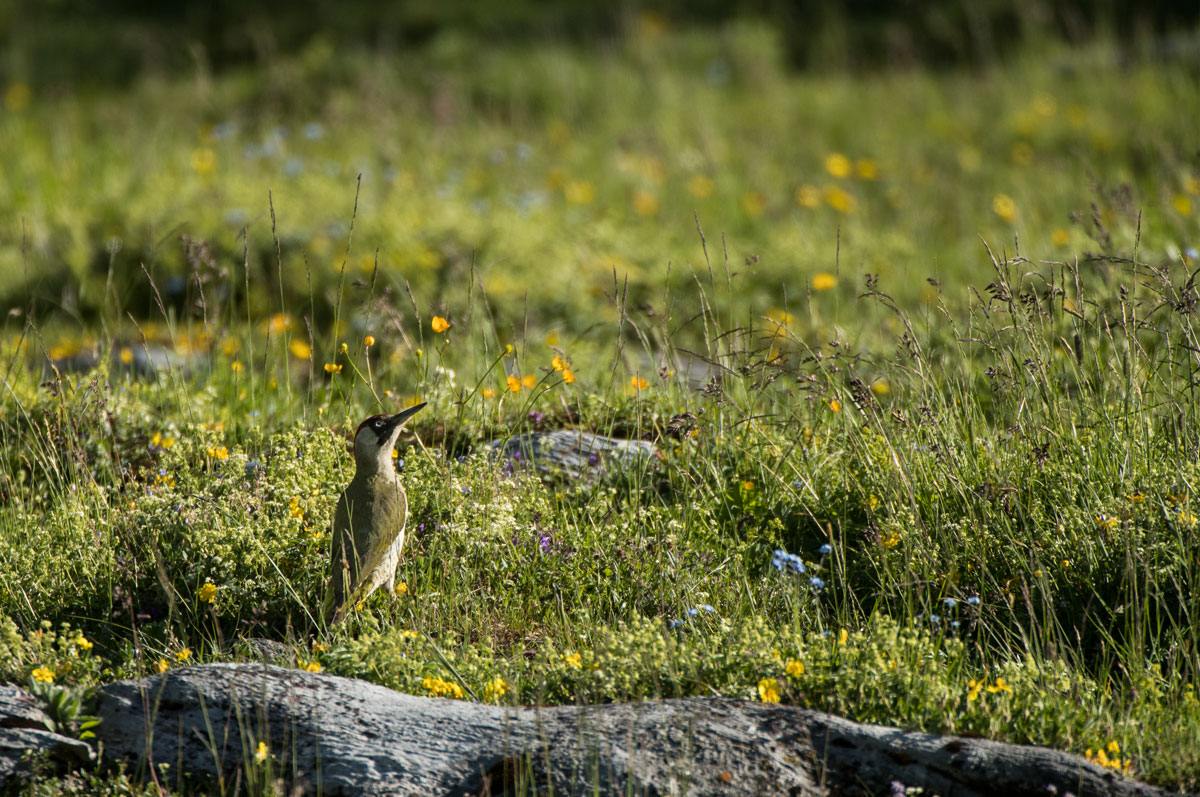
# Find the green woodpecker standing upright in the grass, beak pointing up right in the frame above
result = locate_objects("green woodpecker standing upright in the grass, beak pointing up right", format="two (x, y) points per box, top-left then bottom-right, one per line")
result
(325, 402), (425, 623)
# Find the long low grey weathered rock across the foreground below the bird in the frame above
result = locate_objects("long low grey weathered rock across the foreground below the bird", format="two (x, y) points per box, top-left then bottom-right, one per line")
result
(84, 664), (1163, 796)
